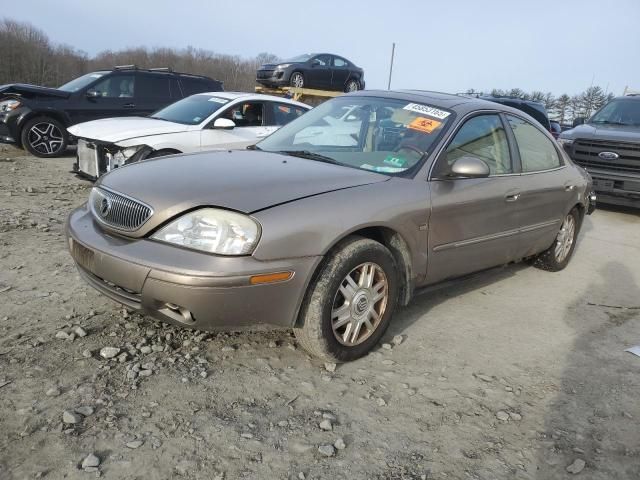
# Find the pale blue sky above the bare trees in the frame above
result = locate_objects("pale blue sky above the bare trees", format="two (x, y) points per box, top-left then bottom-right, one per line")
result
(5, 0), (640, 95)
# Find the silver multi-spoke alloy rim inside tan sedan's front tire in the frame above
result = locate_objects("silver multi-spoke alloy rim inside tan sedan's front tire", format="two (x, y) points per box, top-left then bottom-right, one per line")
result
(331, 262), (389, 347)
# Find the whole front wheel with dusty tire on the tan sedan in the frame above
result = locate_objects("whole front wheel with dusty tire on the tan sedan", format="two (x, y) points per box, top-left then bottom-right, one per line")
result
(294, 236), (399, 363)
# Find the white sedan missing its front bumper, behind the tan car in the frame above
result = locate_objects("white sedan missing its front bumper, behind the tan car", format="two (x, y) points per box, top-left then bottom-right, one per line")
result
(69, 92), (311, 179)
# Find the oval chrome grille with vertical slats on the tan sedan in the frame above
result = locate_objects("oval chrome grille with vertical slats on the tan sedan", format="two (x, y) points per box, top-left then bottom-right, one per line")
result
(89, 187), (153, 232)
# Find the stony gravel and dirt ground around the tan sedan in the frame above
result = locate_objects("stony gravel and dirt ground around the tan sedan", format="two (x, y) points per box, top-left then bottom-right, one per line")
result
(0, 147), (640, 480)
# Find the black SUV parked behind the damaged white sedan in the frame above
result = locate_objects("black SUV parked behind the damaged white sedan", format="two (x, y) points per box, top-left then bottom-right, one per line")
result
(0, 65), (222, 157)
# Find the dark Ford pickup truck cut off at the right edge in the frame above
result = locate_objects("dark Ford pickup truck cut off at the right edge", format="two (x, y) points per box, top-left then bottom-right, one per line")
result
(558, 95), (640, 208)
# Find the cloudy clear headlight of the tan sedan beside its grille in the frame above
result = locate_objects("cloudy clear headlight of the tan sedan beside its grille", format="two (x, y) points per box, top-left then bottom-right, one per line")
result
(151, 208), (260, 255)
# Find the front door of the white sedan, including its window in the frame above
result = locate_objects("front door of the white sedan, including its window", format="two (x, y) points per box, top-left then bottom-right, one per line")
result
(200, 101), (268, 150)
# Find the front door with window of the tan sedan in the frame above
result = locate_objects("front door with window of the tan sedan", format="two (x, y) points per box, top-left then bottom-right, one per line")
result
(427, 113), (519, 283)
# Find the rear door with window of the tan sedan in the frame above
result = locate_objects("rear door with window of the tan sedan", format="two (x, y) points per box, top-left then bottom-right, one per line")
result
(505, 114), (577, 257)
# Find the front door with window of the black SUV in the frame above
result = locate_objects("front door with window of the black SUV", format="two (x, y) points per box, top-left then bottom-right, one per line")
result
(69, 72), (137, 124)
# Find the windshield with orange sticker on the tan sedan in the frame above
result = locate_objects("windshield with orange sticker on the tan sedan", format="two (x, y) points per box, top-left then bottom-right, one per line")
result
(257, 96), (453, 174)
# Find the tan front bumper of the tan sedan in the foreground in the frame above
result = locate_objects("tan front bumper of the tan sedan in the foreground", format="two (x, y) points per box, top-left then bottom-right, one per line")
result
(66, 206), (321, 330)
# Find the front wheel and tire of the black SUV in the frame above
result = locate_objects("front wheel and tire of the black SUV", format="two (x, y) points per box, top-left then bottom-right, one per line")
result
(20, 117), (69, 158)
